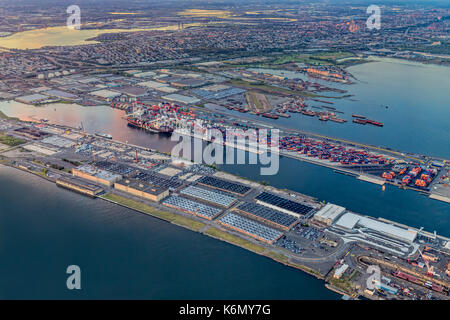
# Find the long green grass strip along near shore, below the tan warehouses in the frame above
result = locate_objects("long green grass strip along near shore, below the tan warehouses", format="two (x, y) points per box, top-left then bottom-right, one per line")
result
(101, 193), (205, 231)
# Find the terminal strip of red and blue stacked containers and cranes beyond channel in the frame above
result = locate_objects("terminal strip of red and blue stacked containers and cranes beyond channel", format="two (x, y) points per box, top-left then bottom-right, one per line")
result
(118, 102), (450, 202)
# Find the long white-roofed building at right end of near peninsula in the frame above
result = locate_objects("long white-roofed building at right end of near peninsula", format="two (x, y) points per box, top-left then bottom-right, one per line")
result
(333, 212), (417, 243)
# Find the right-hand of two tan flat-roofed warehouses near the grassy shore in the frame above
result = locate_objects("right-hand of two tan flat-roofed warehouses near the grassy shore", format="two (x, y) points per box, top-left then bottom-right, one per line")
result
(114, 179), (169, 202)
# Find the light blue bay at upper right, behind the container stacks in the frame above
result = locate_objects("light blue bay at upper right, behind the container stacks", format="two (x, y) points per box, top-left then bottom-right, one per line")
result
(220, 58), (450, 158)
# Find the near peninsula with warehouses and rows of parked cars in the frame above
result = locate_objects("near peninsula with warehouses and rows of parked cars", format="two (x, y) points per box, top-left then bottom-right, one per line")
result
(0, 119), (450, 300)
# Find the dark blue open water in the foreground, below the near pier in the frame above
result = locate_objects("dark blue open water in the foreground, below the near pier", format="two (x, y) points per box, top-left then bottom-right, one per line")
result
(0, 166), (339, 299)
